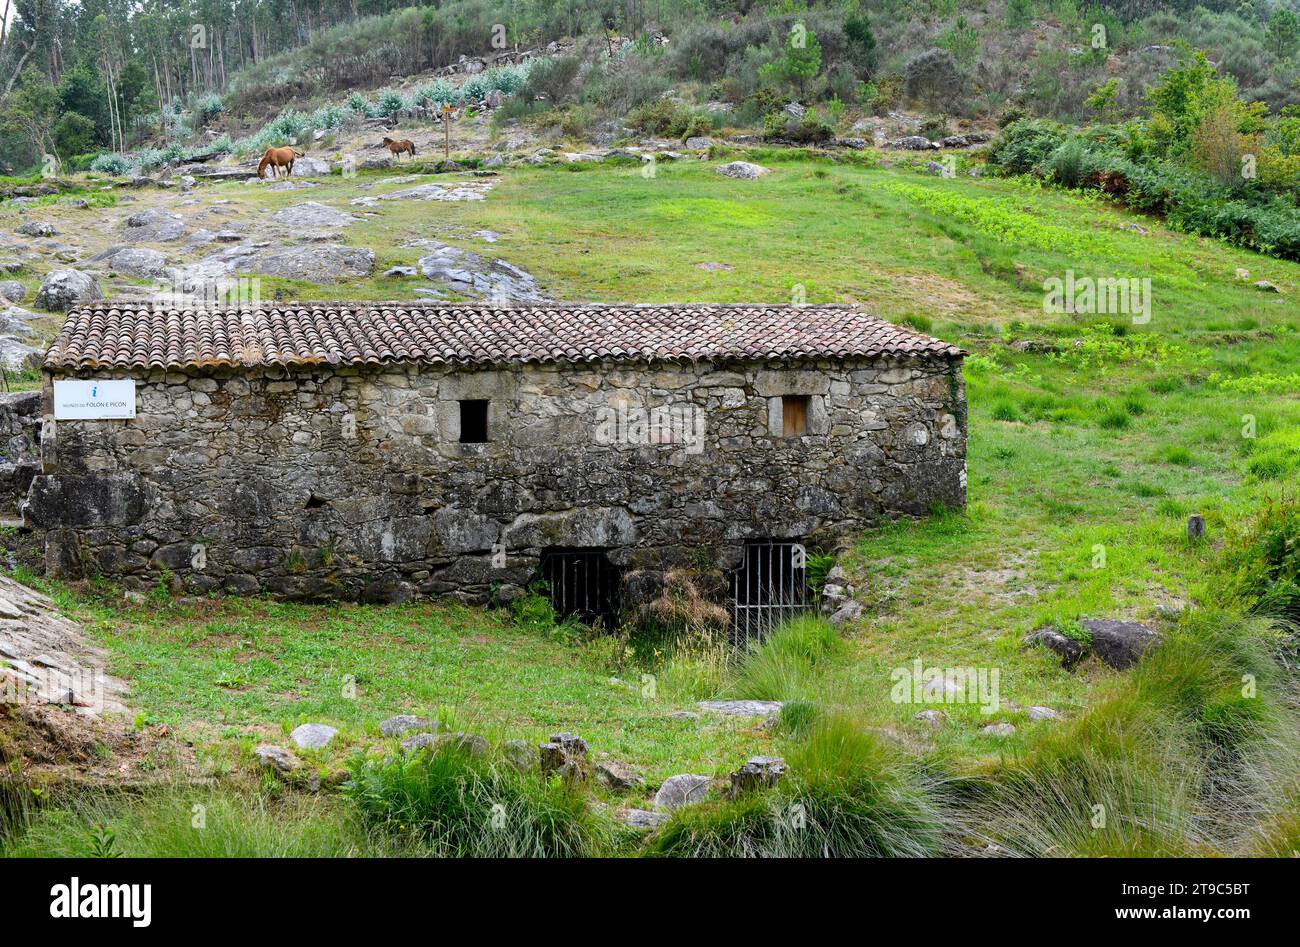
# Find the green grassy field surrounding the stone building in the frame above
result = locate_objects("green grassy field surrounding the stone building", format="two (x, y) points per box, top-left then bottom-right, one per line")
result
(2, 152), (1300, 853)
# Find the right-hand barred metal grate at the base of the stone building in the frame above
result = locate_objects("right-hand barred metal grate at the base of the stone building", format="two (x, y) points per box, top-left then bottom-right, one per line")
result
(732, 540), (809, 644)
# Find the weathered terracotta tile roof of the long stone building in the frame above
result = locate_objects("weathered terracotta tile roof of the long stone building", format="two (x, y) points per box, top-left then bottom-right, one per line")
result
(46, 302), (963, 369)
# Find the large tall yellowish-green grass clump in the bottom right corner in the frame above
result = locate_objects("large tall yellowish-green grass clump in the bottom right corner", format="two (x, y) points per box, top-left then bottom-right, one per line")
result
(974, 609), (1296, 857)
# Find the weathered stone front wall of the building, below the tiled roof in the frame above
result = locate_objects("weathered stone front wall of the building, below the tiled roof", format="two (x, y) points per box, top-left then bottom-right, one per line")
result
(25, 359), (966, 601)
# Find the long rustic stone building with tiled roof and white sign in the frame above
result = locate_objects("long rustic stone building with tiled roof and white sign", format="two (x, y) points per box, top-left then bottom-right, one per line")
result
(23, 303), (966, 613)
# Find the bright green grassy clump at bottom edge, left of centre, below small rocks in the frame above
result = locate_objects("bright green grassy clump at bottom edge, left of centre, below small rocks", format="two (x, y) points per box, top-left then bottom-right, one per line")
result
(343, 741), (610, 859)
